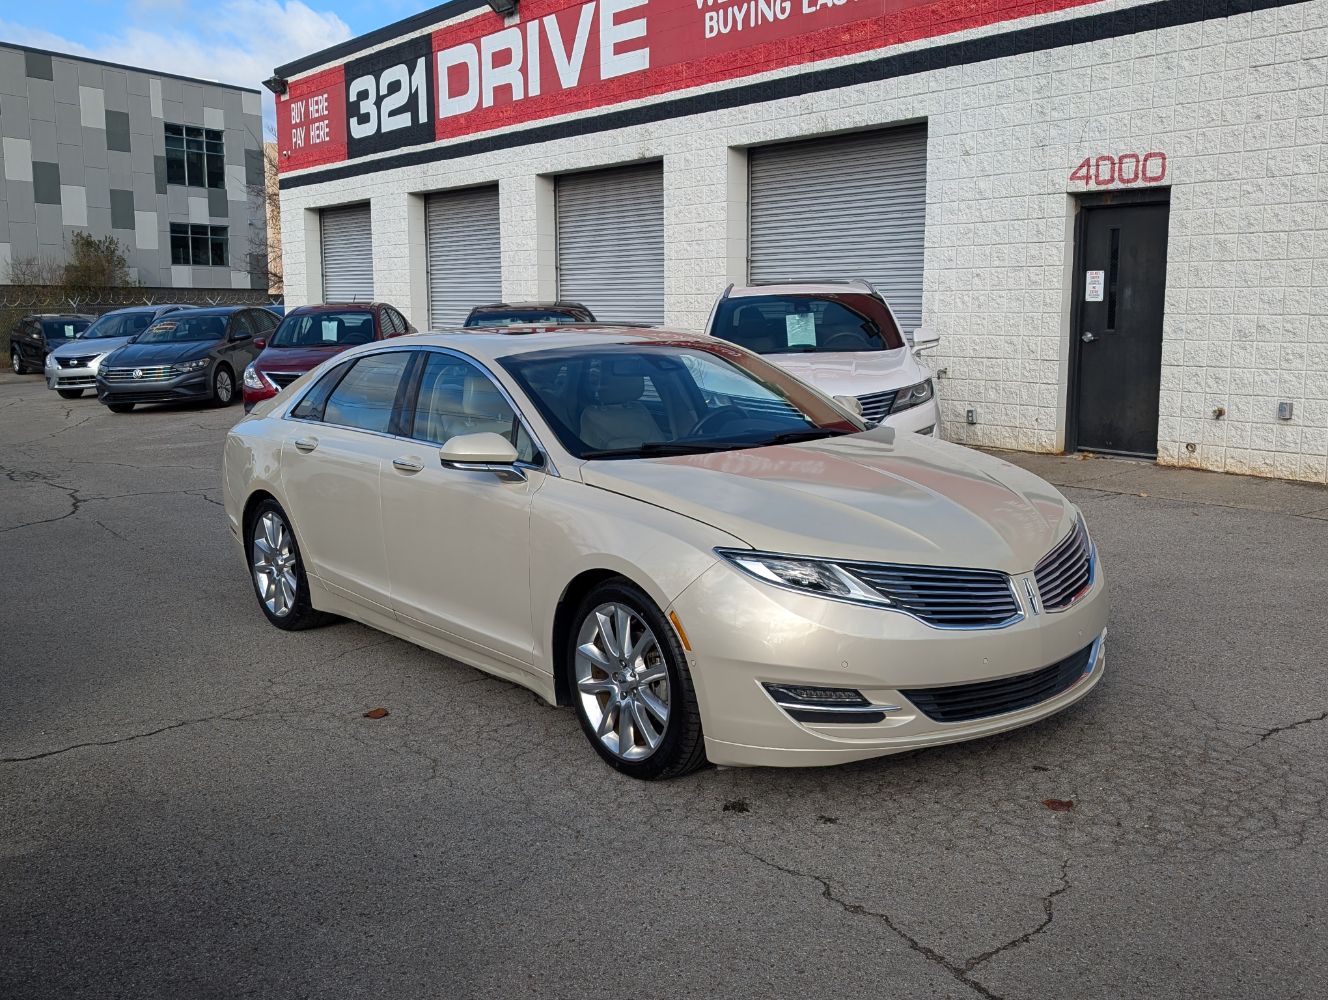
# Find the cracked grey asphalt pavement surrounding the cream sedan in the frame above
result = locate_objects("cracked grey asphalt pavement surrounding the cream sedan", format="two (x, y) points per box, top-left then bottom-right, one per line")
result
(0, 375), (1328, 1000)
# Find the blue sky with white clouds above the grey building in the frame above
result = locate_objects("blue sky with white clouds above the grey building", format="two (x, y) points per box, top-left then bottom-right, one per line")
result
(0, 0), (442, 120)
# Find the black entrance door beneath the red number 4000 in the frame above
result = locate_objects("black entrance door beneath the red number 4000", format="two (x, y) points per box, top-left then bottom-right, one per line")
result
(1070, 193), (1169, 457)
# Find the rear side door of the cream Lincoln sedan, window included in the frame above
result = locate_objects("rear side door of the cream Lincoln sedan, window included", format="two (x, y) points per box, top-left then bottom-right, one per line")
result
(282, 351), (414, 615)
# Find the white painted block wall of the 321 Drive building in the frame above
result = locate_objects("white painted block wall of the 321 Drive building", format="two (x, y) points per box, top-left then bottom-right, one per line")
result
(282, 0), (1328, 482)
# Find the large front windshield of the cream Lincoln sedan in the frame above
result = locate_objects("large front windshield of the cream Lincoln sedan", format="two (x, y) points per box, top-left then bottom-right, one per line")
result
(501, 341), (862, 458)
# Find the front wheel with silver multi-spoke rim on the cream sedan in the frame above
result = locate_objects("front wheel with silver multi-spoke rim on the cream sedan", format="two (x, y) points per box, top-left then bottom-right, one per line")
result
(566, 579), (705, 780)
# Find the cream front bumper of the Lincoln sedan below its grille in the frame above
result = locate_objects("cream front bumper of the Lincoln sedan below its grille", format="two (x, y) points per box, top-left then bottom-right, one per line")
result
(671, 563), (1108, 766)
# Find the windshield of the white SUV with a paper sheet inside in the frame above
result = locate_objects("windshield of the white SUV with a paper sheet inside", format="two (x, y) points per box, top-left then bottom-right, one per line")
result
(710, 293), (904, 355)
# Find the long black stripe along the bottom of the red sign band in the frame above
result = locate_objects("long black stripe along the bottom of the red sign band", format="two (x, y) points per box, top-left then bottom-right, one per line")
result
(280, 0), (1308, 190)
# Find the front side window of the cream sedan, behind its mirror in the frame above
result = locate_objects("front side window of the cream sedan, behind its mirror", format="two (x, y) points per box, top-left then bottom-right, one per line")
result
(410, 352), (535, 463)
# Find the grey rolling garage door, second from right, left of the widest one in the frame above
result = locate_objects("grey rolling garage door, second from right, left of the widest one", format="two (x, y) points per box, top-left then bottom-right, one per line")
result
(555, 163), (664, 323)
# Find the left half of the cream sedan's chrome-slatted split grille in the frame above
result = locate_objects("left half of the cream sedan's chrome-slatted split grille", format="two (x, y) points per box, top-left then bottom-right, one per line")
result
(842, 563), (1020, 628)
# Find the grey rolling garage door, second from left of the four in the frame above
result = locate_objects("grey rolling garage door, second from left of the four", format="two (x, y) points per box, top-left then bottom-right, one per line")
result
(425, 187), (502, 329)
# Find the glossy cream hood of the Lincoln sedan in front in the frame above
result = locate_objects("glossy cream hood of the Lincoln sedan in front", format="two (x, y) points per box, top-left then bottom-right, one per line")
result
(582, 426), (1074, 574)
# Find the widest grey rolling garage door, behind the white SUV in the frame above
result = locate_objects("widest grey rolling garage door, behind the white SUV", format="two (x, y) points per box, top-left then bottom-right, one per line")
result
(748, 125), (927, 339)
